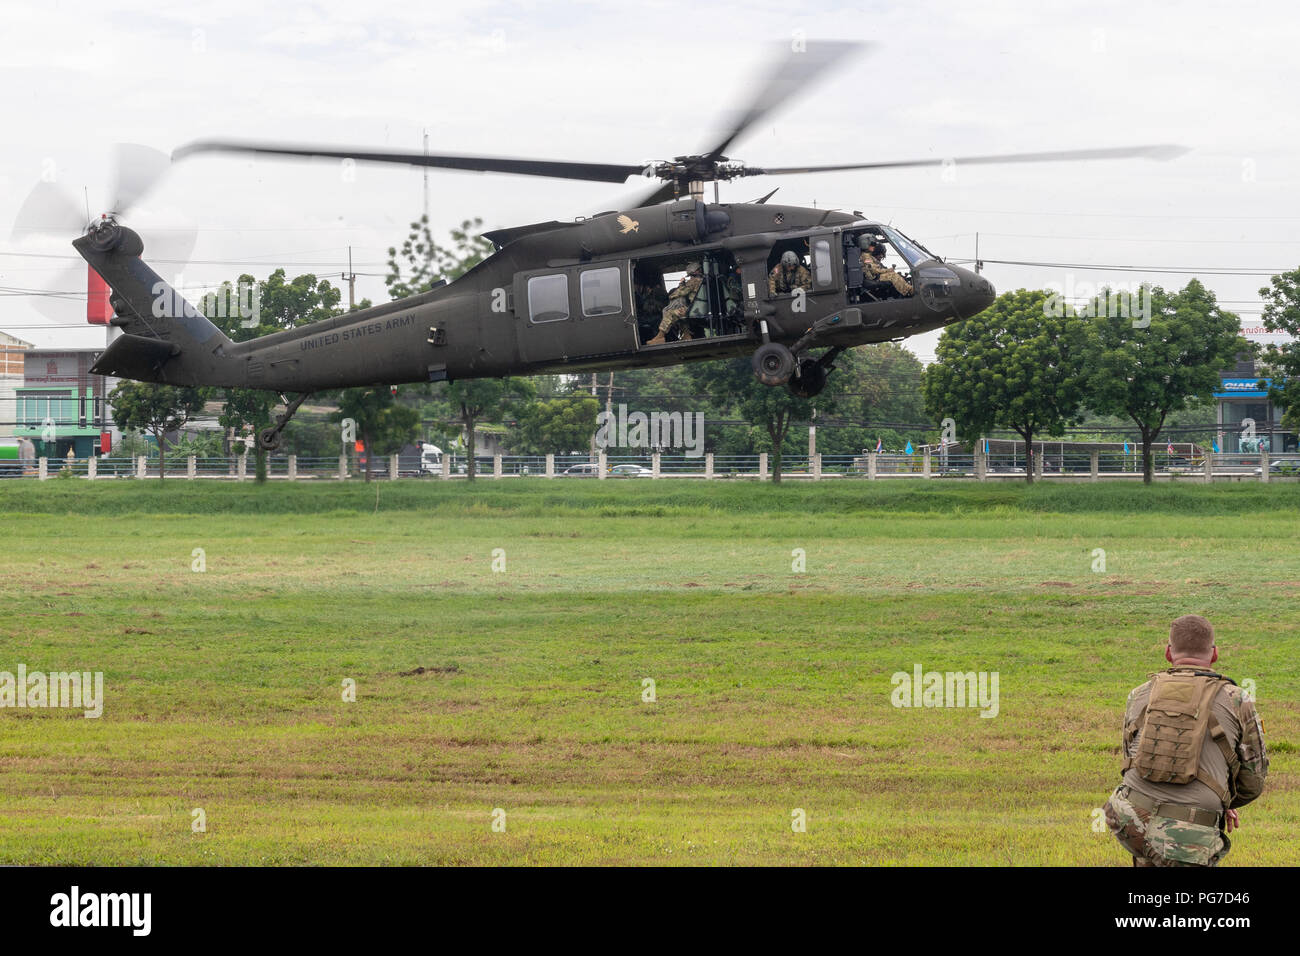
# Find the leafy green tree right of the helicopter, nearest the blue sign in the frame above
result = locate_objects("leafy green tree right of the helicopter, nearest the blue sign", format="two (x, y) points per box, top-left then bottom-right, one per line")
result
(1087, 278), (1249, 484)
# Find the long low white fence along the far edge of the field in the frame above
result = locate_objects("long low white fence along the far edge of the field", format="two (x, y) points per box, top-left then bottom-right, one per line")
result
(0, 451), (1300, 481)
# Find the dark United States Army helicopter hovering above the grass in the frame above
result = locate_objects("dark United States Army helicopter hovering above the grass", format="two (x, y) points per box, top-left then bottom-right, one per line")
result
(73, 42), (1184, 450)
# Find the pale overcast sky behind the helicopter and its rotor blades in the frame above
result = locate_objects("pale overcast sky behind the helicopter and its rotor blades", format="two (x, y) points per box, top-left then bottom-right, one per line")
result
(0, 0), (1300, 360)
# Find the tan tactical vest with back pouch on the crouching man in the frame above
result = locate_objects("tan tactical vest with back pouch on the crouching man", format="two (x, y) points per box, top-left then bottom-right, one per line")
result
(1123, 670), (1240, 806)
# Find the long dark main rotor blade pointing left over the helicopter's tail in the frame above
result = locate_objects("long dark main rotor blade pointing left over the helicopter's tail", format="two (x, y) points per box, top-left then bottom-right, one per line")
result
(172, 139), (646, 182)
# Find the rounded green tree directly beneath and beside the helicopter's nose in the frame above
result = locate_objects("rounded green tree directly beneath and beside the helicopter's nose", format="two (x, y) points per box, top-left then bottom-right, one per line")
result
(926, 289), (1087, 483)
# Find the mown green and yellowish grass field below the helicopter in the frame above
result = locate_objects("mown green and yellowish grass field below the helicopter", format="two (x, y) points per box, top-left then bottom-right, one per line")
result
(0, 479), (1300, 866)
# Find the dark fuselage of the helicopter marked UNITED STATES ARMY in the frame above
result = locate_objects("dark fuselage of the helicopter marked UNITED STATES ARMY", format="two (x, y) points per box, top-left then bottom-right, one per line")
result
(78, 199), (995, 392)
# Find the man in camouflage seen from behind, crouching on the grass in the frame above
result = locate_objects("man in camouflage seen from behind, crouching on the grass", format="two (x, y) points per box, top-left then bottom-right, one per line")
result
(1105, 614), (1269, 866)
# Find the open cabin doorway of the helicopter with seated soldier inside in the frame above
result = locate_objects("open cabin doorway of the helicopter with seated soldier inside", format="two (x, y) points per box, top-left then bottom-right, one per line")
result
(632, 250), (748, 346)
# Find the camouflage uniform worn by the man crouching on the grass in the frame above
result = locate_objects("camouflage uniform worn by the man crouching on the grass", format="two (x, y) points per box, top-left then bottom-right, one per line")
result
(1104, 667), (1269, 866)
